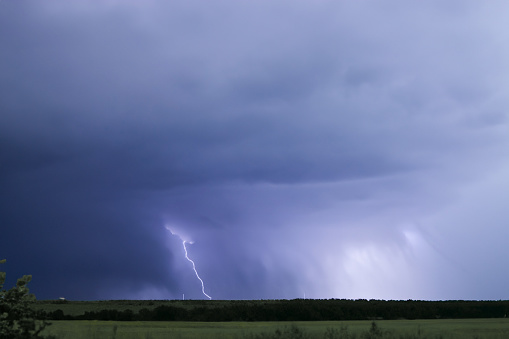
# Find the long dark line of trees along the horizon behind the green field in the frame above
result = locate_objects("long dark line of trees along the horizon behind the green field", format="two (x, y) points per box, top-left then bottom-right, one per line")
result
(41, 299), (509, 321)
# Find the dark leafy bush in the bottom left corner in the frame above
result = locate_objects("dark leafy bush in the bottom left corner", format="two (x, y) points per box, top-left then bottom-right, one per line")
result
(0, 259), (53, 339)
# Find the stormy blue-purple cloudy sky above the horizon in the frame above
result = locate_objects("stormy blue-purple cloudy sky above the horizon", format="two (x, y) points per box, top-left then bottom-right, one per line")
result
(0, 0), (509, 300)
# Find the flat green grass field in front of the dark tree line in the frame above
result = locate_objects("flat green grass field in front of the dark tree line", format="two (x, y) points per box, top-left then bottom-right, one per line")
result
(39, 318), (509, 339)
